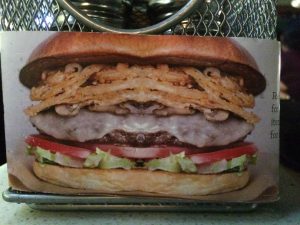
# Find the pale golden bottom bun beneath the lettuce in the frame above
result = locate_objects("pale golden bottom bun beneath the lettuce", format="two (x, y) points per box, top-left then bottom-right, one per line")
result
(33, 162), (249, 196)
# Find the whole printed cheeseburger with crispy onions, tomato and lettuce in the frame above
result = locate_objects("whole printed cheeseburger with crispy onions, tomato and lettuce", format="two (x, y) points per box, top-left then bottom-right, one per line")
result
(20, 33), (266, 197)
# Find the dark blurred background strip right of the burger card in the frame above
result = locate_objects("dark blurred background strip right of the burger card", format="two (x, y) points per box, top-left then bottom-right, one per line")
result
(277, 0), (300, 170)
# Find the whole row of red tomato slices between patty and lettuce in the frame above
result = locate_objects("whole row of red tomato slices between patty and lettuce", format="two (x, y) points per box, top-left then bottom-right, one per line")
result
(25, 135), (257, 165)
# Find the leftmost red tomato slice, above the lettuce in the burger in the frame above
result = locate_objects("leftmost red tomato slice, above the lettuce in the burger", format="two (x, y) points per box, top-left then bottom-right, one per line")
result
(25, 135), (92, 159)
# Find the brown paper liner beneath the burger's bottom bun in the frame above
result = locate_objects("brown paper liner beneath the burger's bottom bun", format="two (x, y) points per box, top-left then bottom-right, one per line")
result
(8, 153), (278, 202)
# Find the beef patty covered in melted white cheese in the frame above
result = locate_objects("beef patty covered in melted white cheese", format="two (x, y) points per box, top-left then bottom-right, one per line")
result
(30, 109), (253, 147)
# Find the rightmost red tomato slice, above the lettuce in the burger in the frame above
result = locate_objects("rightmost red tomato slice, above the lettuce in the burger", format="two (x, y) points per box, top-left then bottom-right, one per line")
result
(189, 143), (257, 164)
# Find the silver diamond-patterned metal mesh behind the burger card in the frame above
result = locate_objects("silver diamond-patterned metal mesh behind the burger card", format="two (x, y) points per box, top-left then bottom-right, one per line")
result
(0, 0), (276, 39)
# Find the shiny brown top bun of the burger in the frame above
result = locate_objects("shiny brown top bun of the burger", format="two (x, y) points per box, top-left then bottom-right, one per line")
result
(20, 32), (266, 94)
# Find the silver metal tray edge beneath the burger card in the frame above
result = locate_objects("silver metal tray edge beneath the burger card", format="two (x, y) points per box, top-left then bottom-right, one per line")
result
(2, 189), (257, 212)
